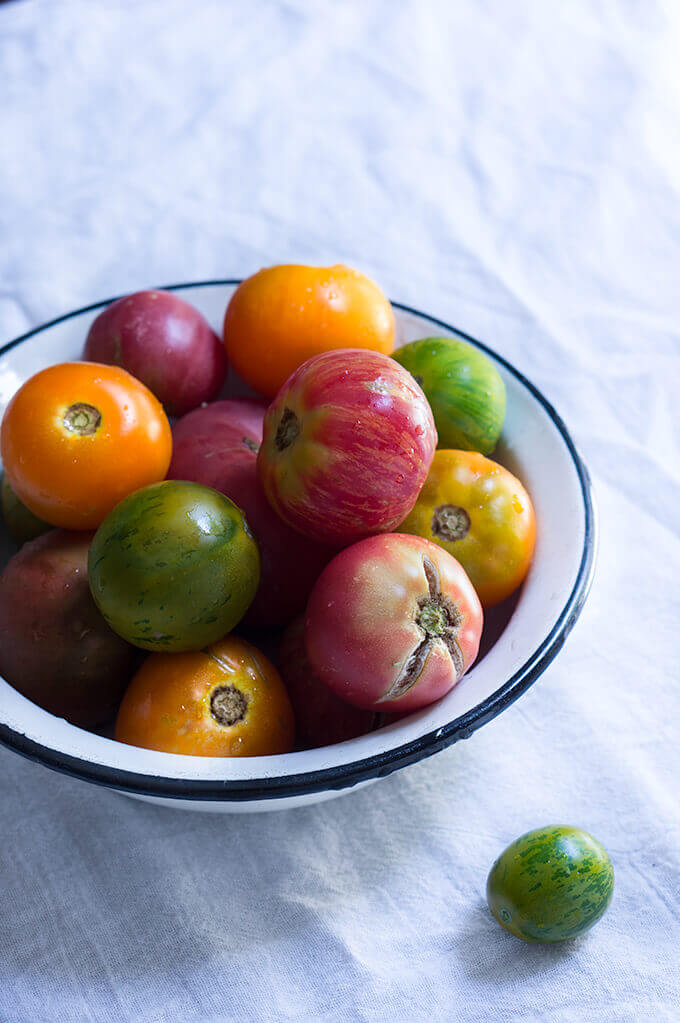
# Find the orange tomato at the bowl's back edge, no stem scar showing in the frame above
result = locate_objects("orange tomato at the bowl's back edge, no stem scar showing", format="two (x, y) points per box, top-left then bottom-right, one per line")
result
(224, 266), (395, 398)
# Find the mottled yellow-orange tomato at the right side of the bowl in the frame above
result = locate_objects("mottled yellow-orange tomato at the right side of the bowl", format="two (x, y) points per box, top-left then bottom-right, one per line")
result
(399, 450), (536, 608)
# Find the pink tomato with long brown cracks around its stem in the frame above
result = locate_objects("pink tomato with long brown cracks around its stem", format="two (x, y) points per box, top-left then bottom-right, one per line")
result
(305, 533), (483, 711)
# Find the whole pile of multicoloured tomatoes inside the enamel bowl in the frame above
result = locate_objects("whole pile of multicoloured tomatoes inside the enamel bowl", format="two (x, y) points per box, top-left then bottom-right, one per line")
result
(0, 266), (536, 756)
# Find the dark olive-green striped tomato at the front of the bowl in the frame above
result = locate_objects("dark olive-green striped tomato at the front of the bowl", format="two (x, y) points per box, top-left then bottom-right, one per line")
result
(88, 480), (260, 652)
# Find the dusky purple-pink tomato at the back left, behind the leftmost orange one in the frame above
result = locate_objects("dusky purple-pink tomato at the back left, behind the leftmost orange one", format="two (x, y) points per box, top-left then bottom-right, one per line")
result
(83, 291), (227, 415)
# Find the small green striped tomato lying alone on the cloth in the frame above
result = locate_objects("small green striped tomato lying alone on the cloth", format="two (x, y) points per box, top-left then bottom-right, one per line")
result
(487, 827), (614, 942)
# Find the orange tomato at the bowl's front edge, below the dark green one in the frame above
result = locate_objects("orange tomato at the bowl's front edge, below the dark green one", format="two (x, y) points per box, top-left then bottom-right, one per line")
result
(116, 635), (294, 757)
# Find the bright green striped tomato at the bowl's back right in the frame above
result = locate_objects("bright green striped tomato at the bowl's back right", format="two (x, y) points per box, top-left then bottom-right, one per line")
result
(393, 338), (505, 454)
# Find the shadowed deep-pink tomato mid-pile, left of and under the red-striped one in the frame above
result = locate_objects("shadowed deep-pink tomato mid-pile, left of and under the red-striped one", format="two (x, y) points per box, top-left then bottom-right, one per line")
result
(168, 399), (335, 626)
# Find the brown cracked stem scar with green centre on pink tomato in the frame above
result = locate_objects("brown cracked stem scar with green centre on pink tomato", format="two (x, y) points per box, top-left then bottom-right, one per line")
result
(379, 558), (464, 703)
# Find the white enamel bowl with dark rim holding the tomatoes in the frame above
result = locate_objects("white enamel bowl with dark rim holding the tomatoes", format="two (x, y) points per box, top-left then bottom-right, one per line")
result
(0, 281), (595, 812)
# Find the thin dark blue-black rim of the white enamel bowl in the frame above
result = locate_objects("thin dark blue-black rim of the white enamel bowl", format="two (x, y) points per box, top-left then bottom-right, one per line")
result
(0, 278), (596, 802)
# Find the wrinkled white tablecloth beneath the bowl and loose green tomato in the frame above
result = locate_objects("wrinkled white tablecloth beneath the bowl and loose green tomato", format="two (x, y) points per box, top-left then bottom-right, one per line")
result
(0, 0), (680, 1023)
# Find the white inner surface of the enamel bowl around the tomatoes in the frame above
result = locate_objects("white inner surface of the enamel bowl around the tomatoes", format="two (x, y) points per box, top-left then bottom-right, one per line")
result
(0, 282), (588, 783)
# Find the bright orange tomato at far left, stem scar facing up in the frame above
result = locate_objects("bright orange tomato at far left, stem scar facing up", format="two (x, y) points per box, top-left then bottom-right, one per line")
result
(2, 362), (172, 529)
